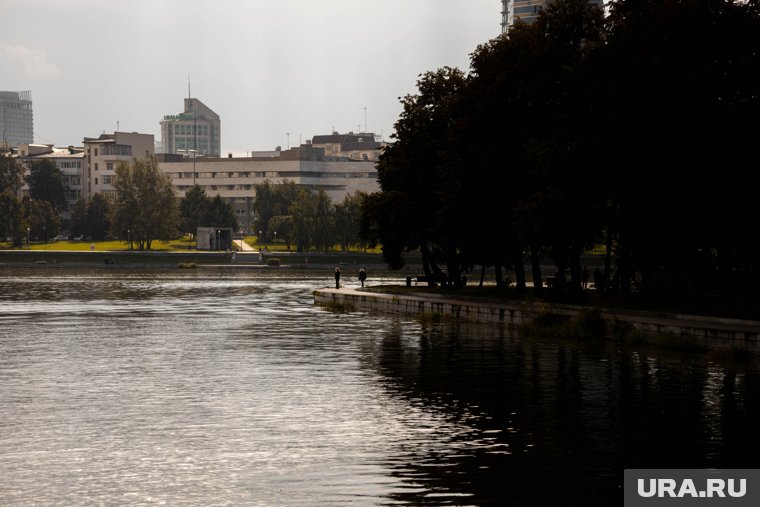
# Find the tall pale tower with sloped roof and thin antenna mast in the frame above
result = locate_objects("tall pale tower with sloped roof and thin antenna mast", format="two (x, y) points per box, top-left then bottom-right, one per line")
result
(161, 98), (222, 157)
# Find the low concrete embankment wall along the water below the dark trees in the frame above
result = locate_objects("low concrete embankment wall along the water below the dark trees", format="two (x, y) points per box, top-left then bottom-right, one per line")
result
(314, 288), (760, 353)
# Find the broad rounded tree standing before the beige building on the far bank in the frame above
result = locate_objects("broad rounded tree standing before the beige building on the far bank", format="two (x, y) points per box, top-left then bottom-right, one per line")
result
(110, 157), (179, 250)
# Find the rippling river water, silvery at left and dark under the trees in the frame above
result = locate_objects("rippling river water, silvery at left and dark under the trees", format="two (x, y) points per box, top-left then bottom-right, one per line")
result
(0, 269), (760, 507)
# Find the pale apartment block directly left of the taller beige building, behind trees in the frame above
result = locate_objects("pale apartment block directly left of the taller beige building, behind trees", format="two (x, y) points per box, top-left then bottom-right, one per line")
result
(17, 144), (87, 220)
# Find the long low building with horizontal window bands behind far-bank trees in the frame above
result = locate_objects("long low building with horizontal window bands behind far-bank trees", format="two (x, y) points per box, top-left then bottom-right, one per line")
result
(158, 144), (379, 233)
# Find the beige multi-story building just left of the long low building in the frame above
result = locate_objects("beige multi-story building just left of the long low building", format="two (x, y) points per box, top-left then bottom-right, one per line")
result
(83, 132), (154, 199)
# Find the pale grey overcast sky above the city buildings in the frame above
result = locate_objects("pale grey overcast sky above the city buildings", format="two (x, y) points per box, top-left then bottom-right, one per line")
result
(0, 0), (501, 156)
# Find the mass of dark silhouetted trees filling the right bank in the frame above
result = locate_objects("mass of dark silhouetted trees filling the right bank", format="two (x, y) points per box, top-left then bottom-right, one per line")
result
(362, 0), (760, 300)
